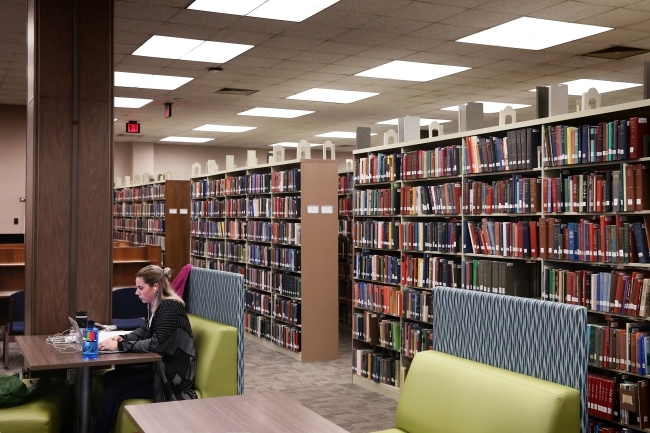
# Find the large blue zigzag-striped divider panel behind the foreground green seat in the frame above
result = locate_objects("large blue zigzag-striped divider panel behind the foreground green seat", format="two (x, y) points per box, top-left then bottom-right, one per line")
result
(433, 287), (588, 433)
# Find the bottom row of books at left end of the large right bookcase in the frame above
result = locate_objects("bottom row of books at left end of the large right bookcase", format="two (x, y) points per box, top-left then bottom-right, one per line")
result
(352, 350), (398, 387)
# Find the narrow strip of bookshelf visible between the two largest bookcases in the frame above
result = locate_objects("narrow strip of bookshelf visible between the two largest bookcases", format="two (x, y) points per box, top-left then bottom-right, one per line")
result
(339, 170), (354, 329)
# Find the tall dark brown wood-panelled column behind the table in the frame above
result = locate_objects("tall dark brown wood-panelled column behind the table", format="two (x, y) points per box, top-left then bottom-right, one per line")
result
(25, 0), (113, 335)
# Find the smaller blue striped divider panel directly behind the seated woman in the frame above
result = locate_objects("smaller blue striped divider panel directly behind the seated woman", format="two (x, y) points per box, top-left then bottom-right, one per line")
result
(184, 267), (244, 394)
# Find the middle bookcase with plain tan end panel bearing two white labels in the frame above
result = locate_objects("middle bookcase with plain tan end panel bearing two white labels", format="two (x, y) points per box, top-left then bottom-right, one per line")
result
(190, 159), (338, 362)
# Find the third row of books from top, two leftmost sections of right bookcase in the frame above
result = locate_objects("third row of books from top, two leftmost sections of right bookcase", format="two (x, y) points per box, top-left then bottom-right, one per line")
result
(352, 219), (461, 253)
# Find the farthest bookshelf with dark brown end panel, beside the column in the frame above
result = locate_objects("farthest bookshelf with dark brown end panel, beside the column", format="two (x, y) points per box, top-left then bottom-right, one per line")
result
(113, 180), (190, 275)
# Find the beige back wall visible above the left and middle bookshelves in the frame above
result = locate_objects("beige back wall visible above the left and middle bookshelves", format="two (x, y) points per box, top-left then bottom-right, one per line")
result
(114, 143), (352, 178)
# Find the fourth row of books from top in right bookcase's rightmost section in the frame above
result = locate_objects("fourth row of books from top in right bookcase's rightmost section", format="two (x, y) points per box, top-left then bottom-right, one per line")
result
(542, 267), (650, 317)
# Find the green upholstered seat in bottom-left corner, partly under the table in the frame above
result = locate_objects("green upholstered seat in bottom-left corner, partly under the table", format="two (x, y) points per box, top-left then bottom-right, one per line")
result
(0, 379), (72, 433)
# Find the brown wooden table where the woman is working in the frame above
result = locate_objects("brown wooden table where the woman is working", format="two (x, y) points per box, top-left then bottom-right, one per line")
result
(16, 335), (162, 433)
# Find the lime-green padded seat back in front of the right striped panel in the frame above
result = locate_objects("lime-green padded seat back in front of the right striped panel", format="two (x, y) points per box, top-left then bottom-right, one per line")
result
(376, 351), (580, 433)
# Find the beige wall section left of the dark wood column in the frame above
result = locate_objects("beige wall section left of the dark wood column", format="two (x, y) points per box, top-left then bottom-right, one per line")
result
(0, 105), (27, 234)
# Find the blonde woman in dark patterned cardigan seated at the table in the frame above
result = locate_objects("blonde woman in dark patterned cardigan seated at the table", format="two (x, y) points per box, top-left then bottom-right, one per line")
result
(95, 265), (197, 433)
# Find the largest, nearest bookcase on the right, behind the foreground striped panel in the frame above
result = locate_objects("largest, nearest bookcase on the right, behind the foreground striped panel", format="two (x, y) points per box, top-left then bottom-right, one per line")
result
(352, 100), (650, 412)
